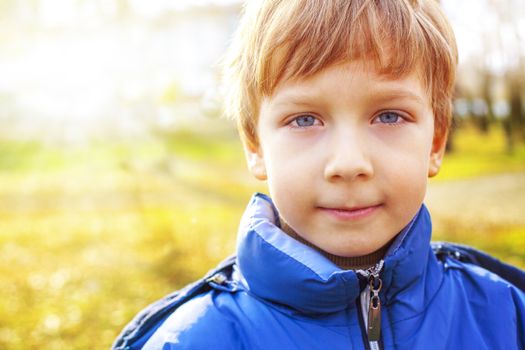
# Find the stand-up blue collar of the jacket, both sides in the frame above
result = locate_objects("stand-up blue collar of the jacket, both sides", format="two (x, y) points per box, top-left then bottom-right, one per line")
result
(237, 193), (440, 314)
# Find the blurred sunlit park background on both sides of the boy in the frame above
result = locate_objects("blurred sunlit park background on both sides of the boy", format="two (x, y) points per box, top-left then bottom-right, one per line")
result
(0, 0), (525, 349)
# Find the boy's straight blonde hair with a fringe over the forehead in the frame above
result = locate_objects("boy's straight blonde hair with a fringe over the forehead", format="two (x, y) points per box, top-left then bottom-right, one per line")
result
(225, 0), (457, 146)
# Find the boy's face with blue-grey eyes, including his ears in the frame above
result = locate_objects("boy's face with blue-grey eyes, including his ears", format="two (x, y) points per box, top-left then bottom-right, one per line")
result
(246, 61), (446, 257)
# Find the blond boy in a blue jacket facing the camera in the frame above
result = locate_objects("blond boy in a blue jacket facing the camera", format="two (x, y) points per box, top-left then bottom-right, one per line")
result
(115, 0), (525, 349)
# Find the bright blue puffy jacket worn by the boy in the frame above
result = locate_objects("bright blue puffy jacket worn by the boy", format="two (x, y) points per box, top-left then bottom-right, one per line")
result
(118, 194), (525, 350)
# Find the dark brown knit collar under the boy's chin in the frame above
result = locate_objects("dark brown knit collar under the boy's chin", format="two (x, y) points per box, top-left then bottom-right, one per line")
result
(281, 219), (390, 270)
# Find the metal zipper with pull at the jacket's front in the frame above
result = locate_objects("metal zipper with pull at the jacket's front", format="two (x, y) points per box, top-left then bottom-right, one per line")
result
(356, 260), (384, 350)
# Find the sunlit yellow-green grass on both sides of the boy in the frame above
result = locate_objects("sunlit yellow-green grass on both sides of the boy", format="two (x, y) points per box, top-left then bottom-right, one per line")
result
(0, 123), (525, 350)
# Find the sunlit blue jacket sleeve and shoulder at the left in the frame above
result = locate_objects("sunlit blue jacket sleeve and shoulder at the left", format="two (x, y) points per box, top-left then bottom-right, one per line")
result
(143, 292), (243, 350)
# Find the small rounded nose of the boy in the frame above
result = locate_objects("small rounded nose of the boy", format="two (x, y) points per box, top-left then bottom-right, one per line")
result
(324, 132), (374, 182)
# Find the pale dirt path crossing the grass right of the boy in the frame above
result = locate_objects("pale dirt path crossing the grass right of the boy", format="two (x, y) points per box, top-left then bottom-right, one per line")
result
(425, 173), (525, 225)
